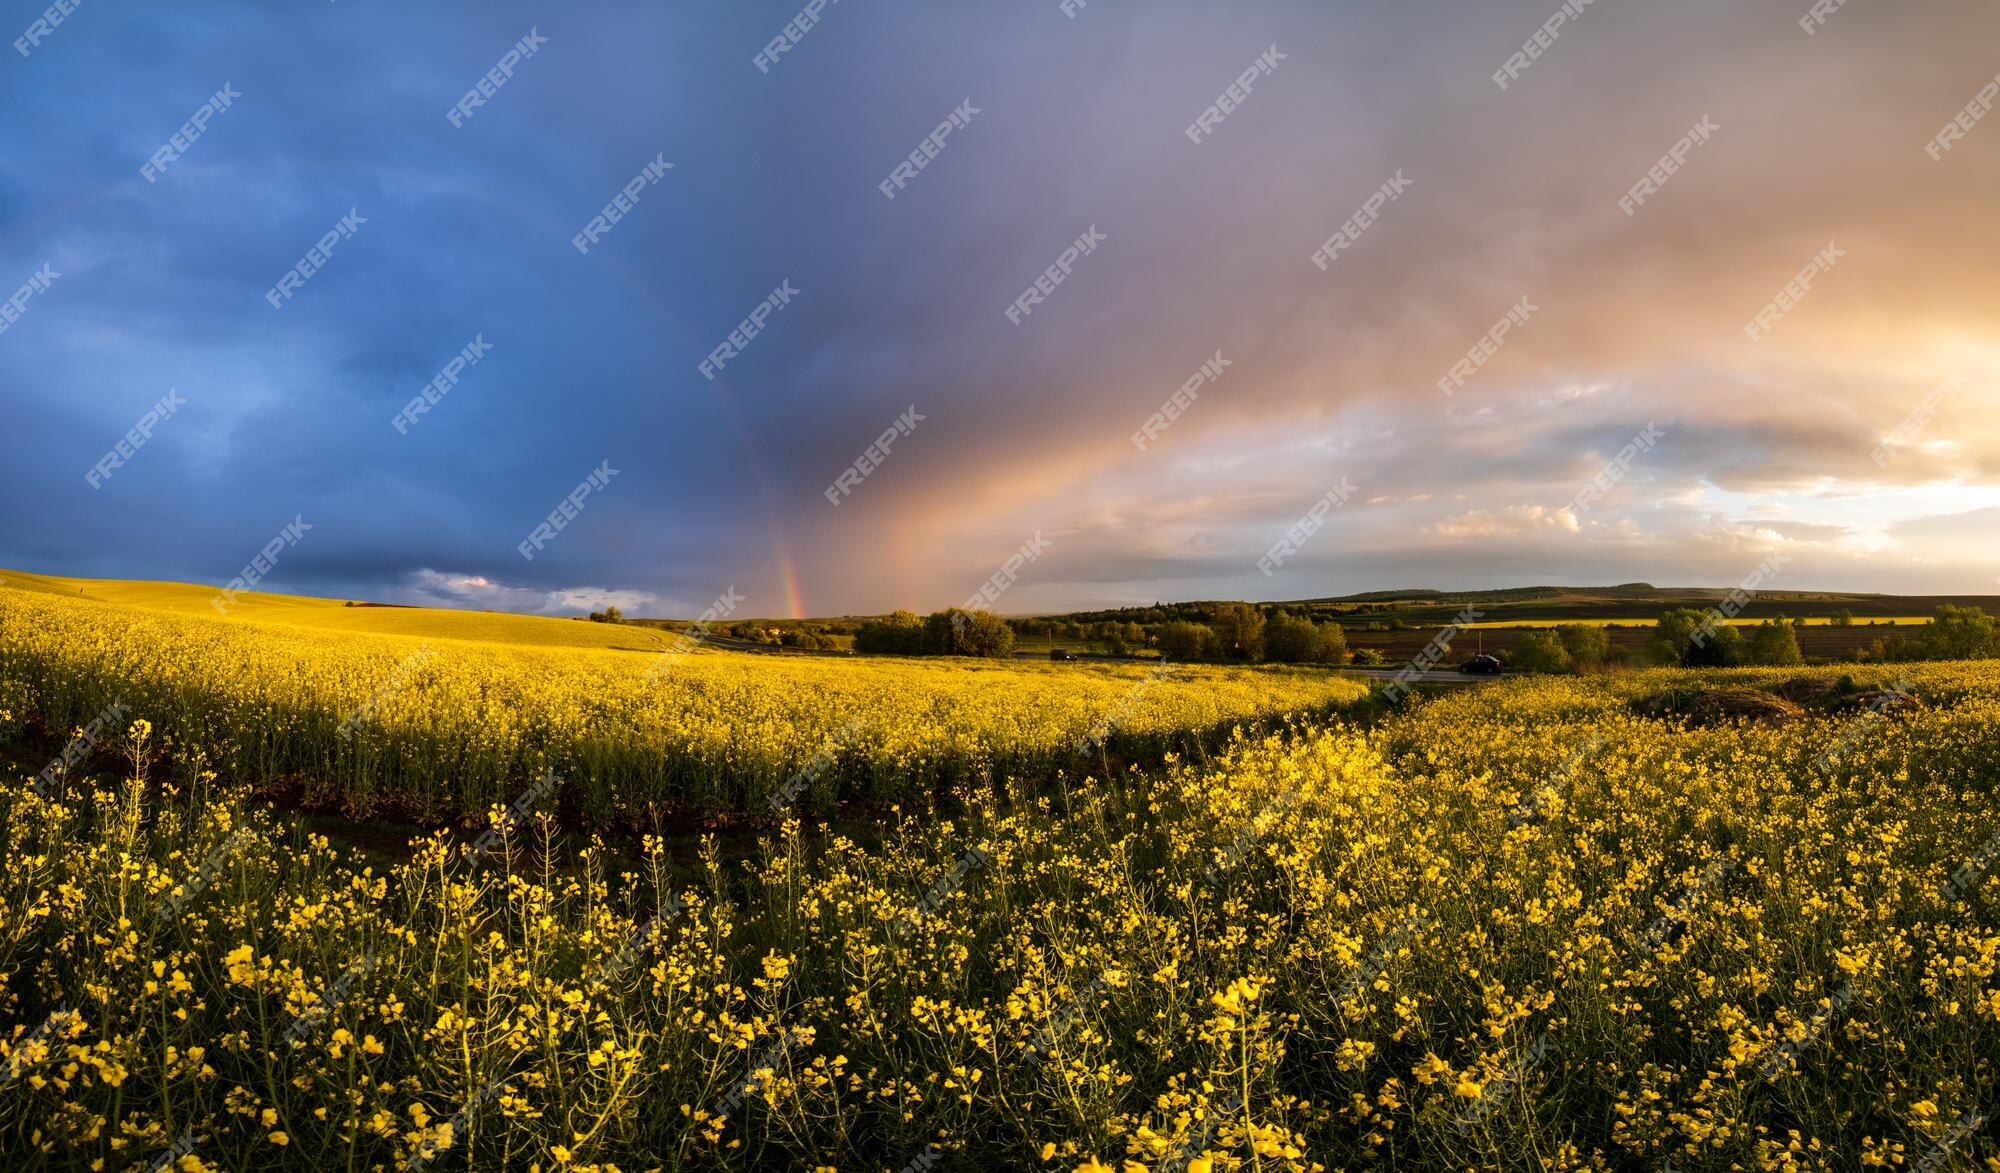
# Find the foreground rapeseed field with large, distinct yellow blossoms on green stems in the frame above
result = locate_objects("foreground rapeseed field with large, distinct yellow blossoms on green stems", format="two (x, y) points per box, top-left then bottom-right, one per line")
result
(0, 636), (2000, 1173)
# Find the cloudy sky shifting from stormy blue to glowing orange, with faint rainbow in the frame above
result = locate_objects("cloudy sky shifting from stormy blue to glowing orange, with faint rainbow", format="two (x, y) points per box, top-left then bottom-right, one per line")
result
(0, 0), (2000, 615)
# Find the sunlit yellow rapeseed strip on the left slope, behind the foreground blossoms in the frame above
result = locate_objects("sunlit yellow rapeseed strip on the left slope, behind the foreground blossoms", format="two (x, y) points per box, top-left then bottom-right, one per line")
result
(0, 576), (1366, 816)
